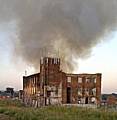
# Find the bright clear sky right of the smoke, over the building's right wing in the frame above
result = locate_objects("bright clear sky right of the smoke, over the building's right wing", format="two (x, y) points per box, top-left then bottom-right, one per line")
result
(76, 31), (117, 93)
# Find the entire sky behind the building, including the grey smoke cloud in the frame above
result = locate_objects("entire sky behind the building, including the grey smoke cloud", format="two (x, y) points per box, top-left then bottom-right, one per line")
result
(0, 0), (117, 93)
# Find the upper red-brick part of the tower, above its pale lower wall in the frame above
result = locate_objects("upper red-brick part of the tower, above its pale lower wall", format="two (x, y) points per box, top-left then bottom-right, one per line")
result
(40, 57), (60, 85)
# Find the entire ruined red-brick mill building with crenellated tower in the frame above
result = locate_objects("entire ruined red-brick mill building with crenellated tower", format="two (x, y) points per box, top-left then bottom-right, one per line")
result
(23, 57), (101, 106)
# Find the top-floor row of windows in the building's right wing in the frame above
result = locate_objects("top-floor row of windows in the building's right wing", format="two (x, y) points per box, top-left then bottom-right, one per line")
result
(67, 77), (96, 83)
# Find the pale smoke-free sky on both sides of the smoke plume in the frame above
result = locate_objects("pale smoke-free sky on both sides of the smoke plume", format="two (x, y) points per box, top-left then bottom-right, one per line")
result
(0, 25), (117, 93)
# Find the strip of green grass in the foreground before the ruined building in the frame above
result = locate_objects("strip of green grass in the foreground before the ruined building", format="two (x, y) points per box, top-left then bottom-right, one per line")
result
(0, 101), (117, 120)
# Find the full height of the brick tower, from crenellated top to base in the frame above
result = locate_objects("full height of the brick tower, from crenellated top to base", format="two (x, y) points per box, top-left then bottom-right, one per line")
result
(40, 57), (61, 105)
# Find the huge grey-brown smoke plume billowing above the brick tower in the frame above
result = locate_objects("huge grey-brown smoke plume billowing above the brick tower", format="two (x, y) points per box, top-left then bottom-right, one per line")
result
(0, 0), (117, 71)
